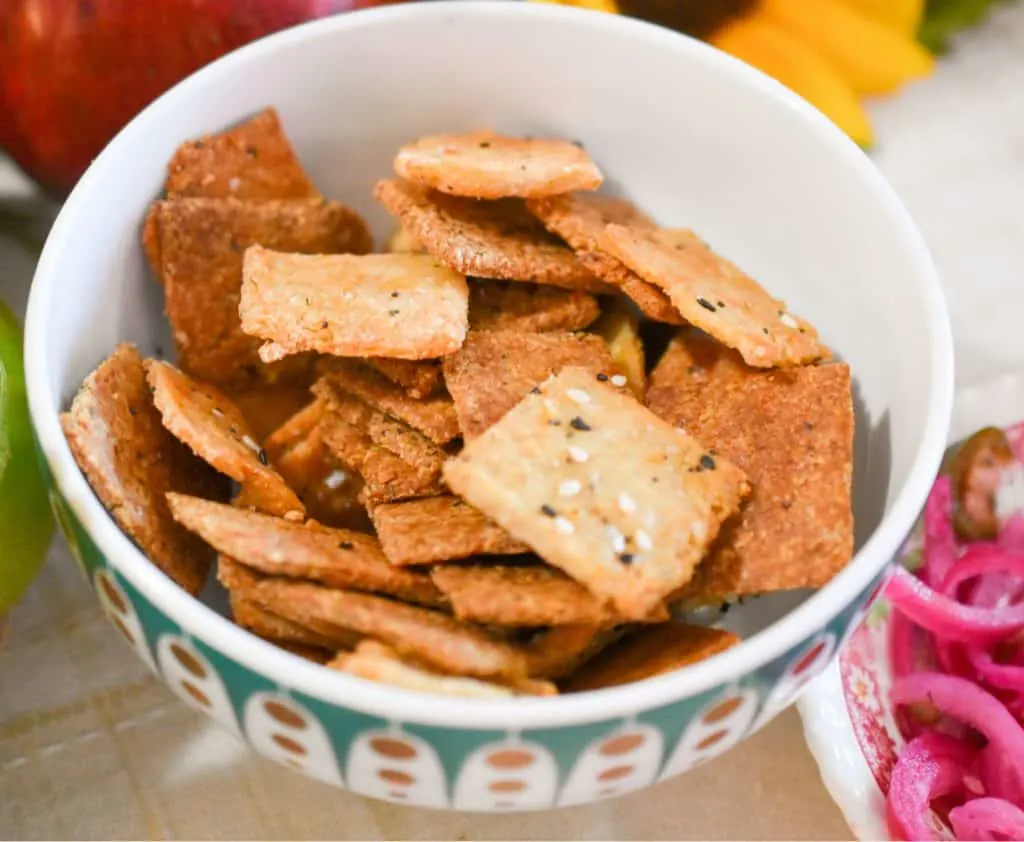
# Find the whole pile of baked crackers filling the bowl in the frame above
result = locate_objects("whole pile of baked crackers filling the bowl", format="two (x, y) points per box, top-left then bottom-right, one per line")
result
(62, 109), (853, 698)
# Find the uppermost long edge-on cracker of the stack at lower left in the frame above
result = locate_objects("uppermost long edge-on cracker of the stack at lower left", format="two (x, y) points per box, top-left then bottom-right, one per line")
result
(167, 494), (445, 605)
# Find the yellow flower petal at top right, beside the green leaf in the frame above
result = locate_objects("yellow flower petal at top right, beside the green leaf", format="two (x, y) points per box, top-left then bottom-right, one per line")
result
(761, 0), (934, 93)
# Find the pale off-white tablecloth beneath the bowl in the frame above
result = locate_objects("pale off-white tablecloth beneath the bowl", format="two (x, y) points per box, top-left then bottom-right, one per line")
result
(0, 6), (1024, 839)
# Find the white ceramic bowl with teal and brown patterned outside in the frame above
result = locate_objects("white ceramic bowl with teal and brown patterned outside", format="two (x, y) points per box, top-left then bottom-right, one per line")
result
(26, 2), (952, 810)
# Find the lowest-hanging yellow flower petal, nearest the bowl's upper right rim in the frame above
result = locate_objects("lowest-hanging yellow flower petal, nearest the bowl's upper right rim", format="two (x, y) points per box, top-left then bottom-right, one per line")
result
(711, 16), (874, 148)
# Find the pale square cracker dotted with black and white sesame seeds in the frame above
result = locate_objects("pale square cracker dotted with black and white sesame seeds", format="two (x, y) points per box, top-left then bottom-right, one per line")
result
(444, 369), (749, 620)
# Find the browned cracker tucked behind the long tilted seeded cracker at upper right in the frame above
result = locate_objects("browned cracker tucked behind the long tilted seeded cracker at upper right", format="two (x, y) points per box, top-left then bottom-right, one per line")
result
(526, 194), (683, 325)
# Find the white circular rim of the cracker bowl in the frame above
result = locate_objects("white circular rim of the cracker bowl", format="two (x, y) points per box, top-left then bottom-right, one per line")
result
(25, 0), (953, 730)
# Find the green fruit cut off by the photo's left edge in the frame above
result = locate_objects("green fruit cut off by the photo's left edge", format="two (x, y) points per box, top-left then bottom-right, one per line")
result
(0, 302), (53, 615)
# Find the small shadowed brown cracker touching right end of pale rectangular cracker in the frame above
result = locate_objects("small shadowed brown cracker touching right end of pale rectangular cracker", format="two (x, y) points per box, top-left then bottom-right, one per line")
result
(469, 279), (601, 333)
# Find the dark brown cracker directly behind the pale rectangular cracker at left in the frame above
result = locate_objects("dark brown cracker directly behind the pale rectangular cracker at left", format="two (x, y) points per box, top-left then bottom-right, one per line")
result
(149, 199), (372, 385)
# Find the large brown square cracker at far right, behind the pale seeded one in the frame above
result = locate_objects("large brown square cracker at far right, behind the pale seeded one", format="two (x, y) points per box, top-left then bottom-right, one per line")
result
(647, 331), (854, 601)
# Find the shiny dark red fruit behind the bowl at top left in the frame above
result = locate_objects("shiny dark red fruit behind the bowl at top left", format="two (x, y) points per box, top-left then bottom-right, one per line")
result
(0, 0), (413, 196)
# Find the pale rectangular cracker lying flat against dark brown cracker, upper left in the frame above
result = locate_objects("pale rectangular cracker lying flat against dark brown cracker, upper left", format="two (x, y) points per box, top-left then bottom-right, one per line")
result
(239, 246), (469, 363)
